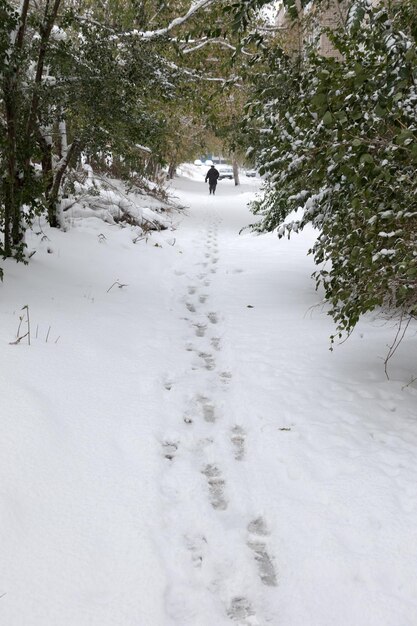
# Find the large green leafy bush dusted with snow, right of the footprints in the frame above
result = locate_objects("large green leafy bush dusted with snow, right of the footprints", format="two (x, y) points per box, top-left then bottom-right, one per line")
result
(247, 0), (417, 339)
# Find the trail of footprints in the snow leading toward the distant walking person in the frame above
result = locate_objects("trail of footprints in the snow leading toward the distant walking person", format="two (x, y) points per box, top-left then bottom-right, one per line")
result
(162, 210), (277, 626)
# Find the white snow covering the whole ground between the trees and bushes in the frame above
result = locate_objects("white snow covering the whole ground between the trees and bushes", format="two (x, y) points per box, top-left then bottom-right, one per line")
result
(0, 167), (417, 626)
